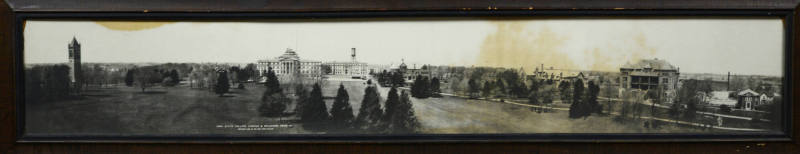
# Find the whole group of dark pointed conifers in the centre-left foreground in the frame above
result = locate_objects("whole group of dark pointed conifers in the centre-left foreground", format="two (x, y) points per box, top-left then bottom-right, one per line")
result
(259, 69), (419, 134)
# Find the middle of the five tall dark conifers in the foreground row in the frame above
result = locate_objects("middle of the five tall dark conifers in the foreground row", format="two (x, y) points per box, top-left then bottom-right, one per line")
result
(354, 85), (383, 132)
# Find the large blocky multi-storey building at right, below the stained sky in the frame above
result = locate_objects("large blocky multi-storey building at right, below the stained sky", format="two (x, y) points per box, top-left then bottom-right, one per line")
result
(619, 58), (680, 102)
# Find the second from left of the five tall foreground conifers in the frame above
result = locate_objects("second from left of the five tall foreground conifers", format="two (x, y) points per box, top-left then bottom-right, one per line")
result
(330, 84), (355, 132)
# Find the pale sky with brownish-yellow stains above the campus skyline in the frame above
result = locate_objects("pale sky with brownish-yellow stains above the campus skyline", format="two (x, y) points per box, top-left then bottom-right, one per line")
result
(24, 18), (784, 75)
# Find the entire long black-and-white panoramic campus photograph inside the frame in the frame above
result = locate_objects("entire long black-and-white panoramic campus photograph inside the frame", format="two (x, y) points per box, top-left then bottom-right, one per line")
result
(21, 18), (787, 136)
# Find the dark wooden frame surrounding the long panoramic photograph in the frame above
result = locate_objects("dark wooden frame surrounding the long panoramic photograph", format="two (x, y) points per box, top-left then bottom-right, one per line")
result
(0, 0), (800, 152)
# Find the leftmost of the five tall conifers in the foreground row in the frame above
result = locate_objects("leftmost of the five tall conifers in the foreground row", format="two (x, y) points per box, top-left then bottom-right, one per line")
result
(300, 84), (330, 131)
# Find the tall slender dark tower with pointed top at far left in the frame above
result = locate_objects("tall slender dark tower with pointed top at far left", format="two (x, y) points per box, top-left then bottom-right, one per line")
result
(67, 37), (83, 93)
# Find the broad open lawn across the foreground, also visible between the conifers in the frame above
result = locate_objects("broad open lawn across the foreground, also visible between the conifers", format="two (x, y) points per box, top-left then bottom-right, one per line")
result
(25, 80), (744, 136)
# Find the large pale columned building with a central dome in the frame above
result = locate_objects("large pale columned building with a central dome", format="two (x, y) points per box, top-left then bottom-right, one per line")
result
(256, 48), (322, 81)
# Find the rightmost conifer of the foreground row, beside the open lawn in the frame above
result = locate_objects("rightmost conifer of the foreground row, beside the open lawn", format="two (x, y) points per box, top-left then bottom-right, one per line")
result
(390, 91), (419, 134)
